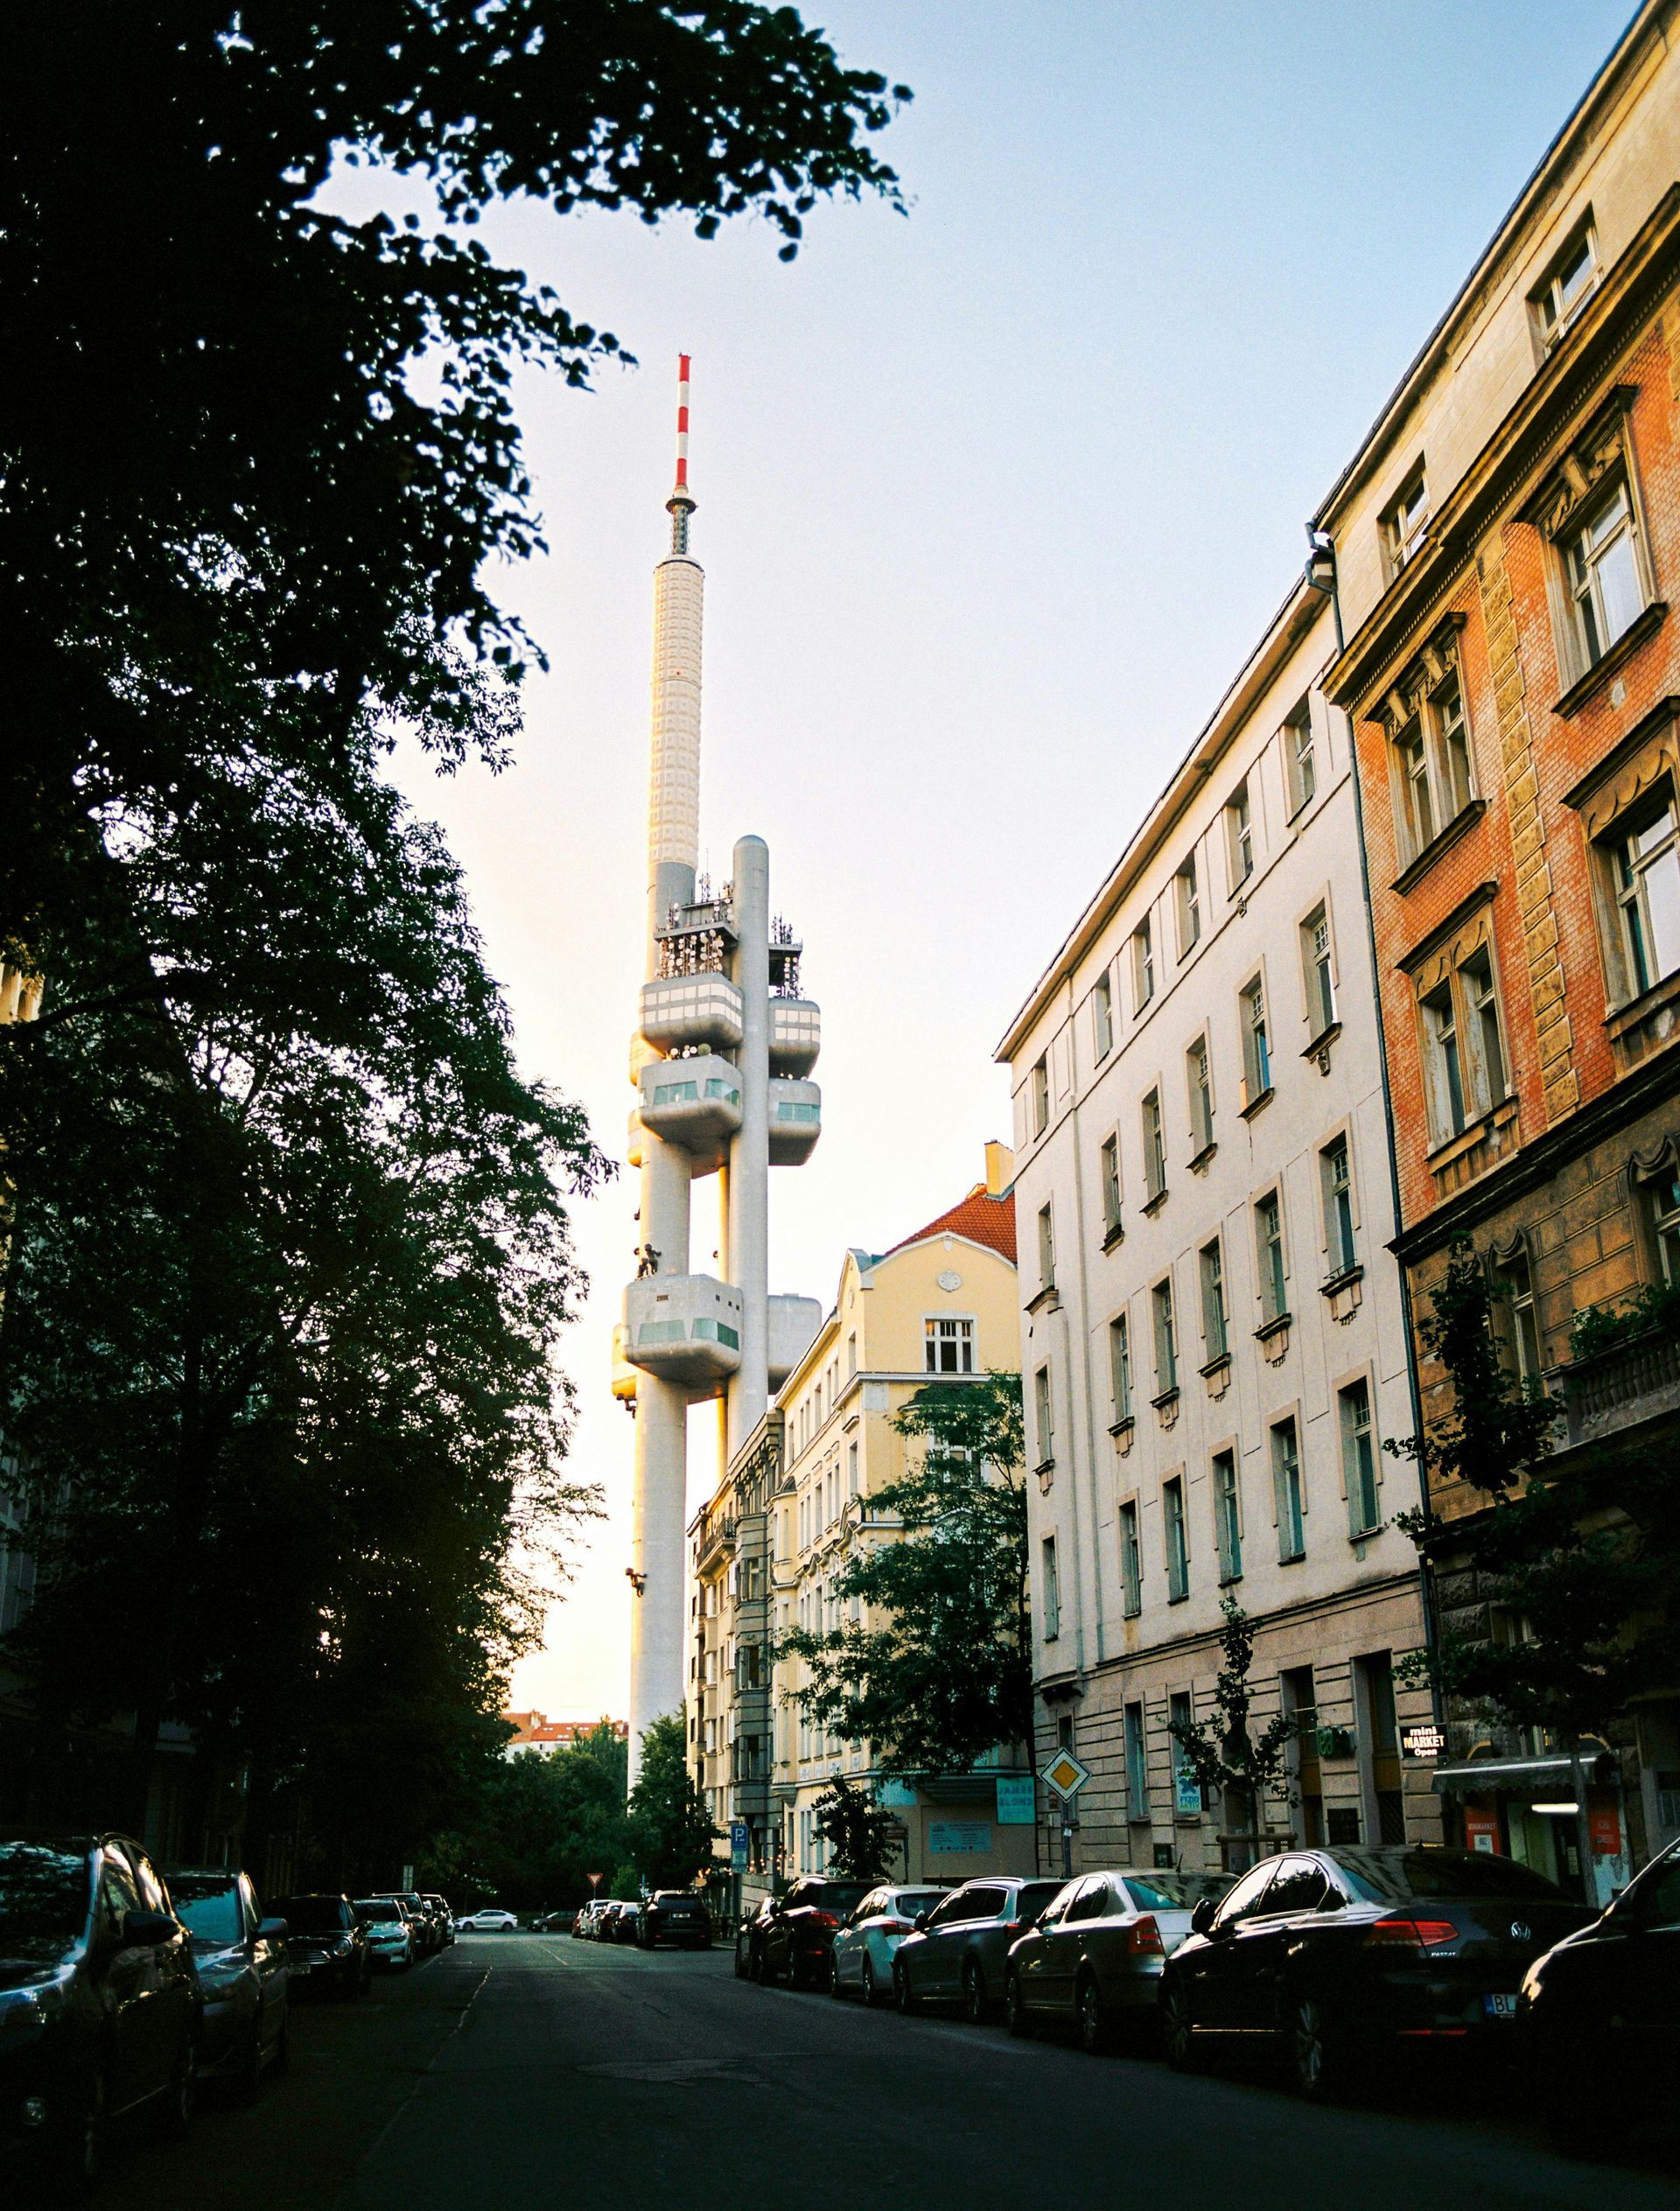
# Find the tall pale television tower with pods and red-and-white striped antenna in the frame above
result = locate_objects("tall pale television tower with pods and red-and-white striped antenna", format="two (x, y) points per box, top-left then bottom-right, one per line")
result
(612, 353), (822, 1780)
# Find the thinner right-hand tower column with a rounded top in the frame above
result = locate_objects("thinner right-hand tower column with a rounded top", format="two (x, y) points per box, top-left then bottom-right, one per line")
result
(730, 836), (769, 1451)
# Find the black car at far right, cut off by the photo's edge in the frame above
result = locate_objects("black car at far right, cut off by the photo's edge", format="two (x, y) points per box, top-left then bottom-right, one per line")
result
(1516, 1842), (1680, 2149)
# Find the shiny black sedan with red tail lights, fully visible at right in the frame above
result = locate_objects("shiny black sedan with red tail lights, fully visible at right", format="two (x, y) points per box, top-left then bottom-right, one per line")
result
(1160, 1844), (1592, 2098)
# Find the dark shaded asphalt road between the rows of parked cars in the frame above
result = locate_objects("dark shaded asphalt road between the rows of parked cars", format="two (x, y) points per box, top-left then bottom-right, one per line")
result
(98, 1935), (1680, 2211)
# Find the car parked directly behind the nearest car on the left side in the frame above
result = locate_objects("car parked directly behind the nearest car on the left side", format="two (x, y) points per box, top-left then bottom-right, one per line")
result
(164, 1866), (291, 2096)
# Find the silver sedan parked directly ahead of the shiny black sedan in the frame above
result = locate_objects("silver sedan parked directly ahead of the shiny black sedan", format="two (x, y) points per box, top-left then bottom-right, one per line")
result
(1004, 1866), (1231, 2052)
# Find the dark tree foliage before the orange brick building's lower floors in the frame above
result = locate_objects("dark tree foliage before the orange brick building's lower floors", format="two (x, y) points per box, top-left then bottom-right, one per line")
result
(1390, 1241), (1680, 1740)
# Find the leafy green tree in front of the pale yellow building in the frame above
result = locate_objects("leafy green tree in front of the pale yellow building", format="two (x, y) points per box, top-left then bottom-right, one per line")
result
(778, 1373), (1032, 1774)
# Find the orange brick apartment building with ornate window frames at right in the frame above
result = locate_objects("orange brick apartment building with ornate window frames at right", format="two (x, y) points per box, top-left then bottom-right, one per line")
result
(1315, 4), (1680, 1897)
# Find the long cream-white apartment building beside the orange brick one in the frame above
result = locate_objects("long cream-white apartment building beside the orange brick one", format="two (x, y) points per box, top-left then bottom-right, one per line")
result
(999, 584), (1439, 1868)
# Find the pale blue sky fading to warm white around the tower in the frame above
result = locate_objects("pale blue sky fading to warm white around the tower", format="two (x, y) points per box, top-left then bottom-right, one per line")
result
(358, 0), (1631, 1718)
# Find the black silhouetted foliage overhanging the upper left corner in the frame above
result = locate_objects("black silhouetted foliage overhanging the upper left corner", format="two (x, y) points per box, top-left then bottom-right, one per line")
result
(0, 0), (895, 948)
